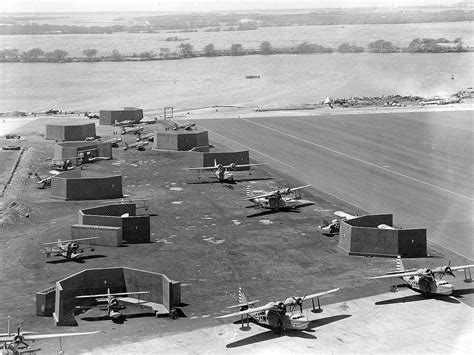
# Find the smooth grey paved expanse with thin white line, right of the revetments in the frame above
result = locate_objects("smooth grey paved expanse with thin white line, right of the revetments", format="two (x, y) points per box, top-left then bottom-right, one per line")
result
(199, 111), (474, 259)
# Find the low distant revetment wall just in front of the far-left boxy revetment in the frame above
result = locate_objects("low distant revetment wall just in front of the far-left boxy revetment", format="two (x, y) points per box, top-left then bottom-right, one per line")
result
(54, 141), (112, 160)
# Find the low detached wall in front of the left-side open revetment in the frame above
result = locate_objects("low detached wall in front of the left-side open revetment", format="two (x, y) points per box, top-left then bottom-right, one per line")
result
(71, 224), (122, 247)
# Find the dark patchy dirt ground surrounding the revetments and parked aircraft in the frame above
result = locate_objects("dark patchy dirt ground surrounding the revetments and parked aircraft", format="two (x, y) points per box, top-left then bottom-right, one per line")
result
(0, 118), (472, 350)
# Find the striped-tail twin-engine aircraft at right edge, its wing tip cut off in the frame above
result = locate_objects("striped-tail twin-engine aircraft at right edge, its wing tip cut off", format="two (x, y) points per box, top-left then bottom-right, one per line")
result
(370, 256), (474, 298)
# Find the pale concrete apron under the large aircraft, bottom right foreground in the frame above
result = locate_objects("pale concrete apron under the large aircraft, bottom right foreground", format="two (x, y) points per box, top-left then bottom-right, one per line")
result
(83, 288), (474, 354)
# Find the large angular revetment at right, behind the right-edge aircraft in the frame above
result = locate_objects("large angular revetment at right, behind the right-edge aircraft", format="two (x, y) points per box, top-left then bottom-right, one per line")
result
(339, 214), (427, 257)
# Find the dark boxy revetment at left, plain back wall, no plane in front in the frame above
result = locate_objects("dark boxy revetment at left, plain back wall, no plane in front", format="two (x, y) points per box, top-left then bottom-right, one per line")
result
(50, 170), (123, 200)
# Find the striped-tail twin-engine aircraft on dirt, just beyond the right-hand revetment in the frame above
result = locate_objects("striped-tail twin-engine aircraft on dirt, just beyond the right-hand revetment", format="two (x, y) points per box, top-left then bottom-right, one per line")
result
(247, 185), (313, 212)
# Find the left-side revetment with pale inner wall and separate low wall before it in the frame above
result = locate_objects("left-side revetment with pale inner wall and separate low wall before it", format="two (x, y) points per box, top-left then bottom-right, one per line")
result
(77, 204), (150, 245)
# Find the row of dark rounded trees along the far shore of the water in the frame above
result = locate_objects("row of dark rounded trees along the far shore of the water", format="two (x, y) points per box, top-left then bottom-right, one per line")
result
(0, 37), (469, 62)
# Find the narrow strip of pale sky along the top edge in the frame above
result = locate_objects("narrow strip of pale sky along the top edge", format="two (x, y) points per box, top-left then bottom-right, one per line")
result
(0, 0), (466, 13)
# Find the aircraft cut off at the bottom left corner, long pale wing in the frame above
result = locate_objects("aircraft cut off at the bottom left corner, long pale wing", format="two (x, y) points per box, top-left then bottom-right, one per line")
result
(0, 321), (100, 355)
